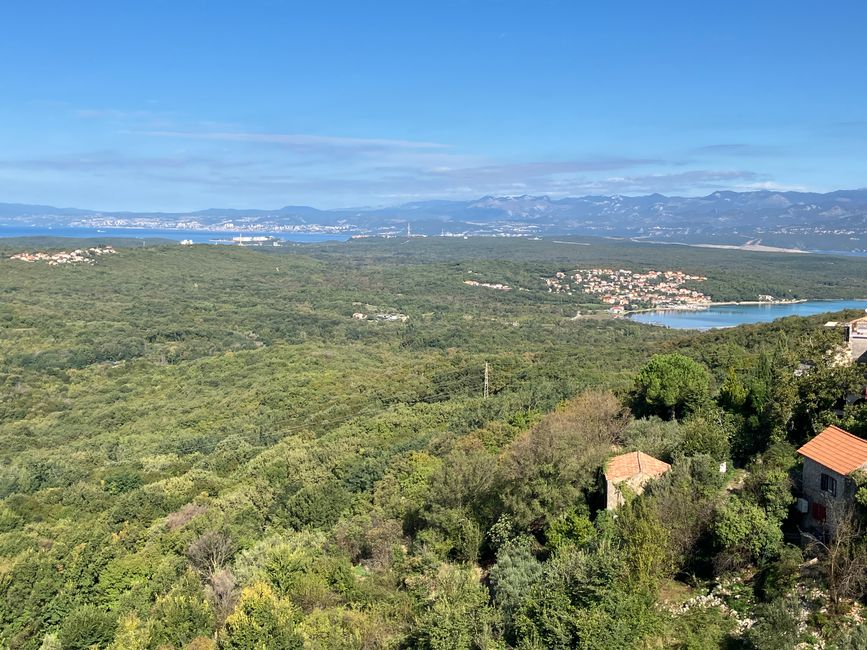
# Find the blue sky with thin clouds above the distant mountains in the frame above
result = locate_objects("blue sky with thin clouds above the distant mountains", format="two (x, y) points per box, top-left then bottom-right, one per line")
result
(0, 0), (867, 210)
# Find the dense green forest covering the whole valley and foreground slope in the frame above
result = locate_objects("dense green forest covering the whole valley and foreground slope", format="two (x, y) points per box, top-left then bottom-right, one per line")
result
(0, 239), (867, 650)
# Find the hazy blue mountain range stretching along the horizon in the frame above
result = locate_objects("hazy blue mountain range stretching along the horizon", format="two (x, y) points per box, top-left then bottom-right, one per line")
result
(0, 189), (867, 252)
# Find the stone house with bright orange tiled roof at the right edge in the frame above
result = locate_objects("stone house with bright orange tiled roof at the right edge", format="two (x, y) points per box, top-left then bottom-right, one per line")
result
(798, 425), (867, 531)
